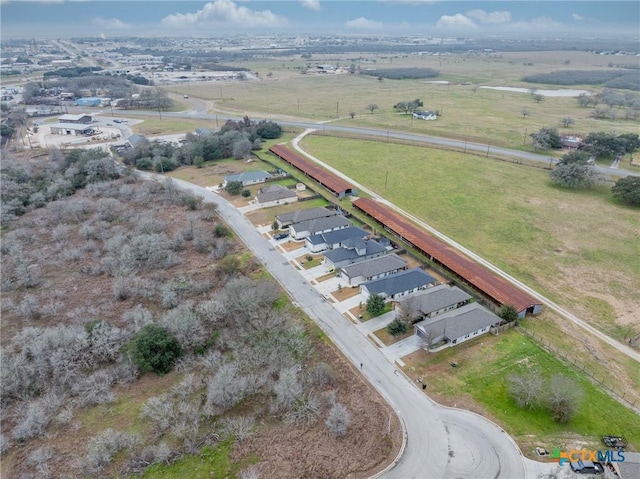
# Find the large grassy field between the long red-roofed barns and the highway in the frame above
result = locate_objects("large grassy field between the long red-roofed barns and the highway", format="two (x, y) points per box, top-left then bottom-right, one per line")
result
(302, 136), (640, 338)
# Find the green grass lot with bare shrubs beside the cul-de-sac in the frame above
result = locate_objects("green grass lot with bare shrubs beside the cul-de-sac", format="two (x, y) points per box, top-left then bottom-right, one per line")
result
(406, 330), (640, 455)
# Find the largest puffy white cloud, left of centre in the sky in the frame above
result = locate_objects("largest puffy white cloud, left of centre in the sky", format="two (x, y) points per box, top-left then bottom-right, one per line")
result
(161, 0), (287, 28)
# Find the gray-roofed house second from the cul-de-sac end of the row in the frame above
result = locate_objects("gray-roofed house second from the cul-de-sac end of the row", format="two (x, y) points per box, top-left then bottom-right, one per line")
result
(400, 284), (473, 320)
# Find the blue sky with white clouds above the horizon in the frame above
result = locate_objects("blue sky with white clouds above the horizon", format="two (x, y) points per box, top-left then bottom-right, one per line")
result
(0, 0), (640, 39)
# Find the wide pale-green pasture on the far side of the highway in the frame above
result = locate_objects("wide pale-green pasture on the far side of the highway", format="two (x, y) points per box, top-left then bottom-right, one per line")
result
(169, 52), (639, 149)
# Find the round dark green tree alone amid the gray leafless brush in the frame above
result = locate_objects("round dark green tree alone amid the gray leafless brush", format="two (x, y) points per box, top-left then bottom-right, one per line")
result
(127, 324), (183, 375)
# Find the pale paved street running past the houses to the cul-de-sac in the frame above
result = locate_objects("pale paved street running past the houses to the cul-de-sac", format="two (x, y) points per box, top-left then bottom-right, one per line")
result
(140, 172), (550, 479)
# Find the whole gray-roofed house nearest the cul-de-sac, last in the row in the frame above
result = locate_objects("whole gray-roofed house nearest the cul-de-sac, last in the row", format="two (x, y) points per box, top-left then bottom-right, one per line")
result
(414, 303), (502, 349)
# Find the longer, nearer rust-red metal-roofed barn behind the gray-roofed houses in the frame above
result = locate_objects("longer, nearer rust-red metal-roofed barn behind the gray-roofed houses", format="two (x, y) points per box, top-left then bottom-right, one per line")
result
(353, 198), (542, 317)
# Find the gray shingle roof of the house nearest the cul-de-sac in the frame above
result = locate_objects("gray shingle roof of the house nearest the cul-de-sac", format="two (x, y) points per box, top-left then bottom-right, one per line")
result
(415, 303), (500, 339)
